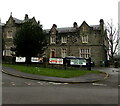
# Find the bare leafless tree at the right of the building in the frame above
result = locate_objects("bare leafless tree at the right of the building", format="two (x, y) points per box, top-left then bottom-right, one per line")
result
(106, 21), (120, 65)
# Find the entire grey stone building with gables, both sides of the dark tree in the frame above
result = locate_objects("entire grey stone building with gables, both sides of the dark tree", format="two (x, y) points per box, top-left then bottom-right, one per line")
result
(3, 14), (108, 65)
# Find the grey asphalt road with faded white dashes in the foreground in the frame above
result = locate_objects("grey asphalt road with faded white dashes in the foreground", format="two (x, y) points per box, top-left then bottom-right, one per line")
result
(2, 67), (119, 104)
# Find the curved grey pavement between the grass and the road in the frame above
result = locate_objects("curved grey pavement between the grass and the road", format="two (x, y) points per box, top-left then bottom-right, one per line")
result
(2, 66), (110, 83)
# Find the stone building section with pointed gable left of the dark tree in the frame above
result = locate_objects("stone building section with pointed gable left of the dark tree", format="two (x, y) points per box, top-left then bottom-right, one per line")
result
(2, 13), (38, 58)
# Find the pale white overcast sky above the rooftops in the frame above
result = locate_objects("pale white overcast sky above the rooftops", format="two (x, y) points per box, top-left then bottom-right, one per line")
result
(0, 0), (120, 29)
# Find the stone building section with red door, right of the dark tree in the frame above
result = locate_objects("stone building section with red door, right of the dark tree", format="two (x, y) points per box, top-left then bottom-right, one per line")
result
(45, 19), (107, 65)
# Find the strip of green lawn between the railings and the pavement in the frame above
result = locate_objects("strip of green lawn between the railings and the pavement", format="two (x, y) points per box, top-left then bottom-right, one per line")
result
(3, 64), (100, 78)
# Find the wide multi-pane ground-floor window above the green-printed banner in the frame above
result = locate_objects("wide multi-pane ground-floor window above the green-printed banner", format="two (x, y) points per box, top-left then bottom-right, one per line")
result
(79, 48), (91, 59)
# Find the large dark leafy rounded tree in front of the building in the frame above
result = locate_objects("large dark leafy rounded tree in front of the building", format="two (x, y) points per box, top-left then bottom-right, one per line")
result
(13, 21), (47, 63)
